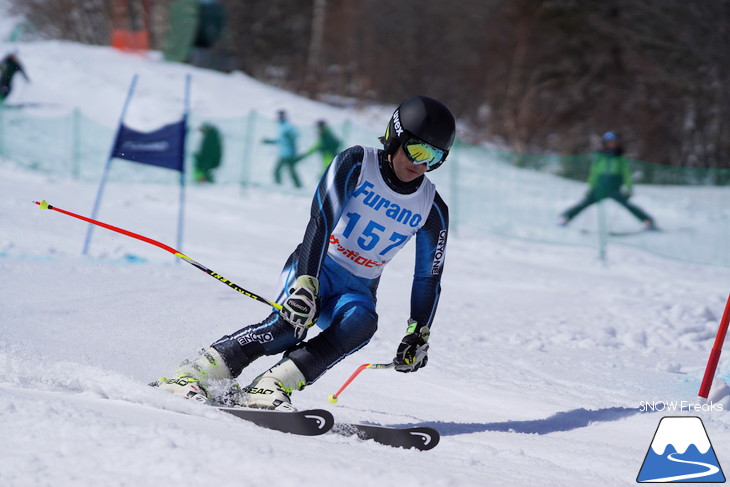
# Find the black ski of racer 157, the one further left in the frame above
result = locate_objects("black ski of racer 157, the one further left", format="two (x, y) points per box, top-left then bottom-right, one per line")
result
(215, 406), (335, 436)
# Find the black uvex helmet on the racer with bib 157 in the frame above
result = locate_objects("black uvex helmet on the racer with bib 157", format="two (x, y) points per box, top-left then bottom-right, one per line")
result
(380, 96), (456, 171)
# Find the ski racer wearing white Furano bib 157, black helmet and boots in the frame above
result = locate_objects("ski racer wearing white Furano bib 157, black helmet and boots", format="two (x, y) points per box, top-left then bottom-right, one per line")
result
(158, 96), (455, 410)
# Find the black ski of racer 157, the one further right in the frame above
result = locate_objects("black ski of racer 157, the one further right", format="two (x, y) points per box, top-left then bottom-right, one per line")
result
(332, 423), (441, 450)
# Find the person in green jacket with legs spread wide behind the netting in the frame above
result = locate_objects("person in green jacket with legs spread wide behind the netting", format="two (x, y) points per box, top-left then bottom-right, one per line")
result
(559, 132), (657, 230)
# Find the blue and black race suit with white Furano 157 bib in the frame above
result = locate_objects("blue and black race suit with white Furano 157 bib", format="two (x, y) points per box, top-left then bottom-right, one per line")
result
(213, 146), (448, 384)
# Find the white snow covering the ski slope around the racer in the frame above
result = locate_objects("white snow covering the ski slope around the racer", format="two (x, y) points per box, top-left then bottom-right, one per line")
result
(0, 20), (730, 487)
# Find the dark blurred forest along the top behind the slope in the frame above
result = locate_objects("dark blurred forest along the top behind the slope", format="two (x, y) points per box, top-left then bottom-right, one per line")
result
(7, 0), (730, 167)
